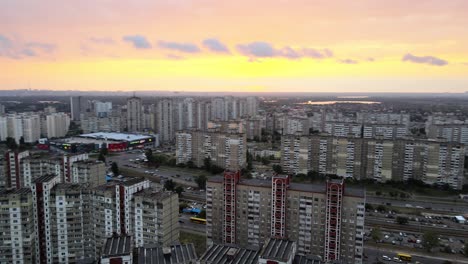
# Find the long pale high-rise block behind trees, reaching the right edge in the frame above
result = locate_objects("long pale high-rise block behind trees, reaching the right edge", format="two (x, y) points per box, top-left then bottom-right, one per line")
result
(281, 135), (465, 189)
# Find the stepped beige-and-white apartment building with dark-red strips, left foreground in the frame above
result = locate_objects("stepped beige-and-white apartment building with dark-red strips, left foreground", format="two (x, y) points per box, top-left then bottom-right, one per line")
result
(31, 175), (179, 263)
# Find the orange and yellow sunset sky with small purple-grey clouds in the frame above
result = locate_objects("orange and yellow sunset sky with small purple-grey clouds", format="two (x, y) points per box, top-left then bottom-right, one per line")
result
(0, 0), (468, 93)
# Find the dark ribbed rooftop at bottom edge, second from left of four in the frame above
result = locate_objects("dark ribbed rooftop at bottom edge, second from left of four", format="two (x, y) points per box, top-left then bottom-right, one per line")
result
(137, 244), (197, 264)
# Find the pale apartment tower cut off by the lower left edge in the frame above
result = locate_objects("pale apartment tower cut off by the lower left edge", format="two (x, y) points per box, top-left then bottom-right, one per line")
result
(0, 188), (35, 264)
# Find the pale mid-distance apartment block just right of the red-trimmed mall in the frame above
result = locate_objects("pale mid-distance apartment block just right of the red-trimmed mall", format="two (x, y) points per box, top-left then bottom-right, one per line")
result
(176, 131), (247, 169)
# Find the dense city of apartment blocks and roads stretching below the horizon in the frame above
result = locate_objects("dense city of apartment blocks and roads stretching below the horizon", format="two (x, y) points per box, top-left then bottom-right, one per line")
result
(0, 92), (468, 263)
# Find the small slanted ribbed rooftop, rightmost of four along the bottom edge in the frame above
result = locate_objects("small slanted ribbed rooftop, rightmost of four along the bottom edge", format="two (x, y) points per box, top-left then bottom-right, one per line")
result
(260, 238), (296, 262)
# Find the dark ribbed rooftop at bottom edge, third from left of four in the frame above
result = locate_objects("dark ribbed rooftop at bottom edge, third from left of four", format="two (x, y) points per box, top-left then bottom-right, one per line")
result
(200, 245), (259, 264)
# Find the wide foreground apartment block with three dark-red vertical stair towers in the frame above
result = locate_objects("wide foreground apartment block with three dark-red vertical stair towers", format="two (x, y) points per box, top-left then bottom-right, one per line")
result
(206, 172), (365, 263)
